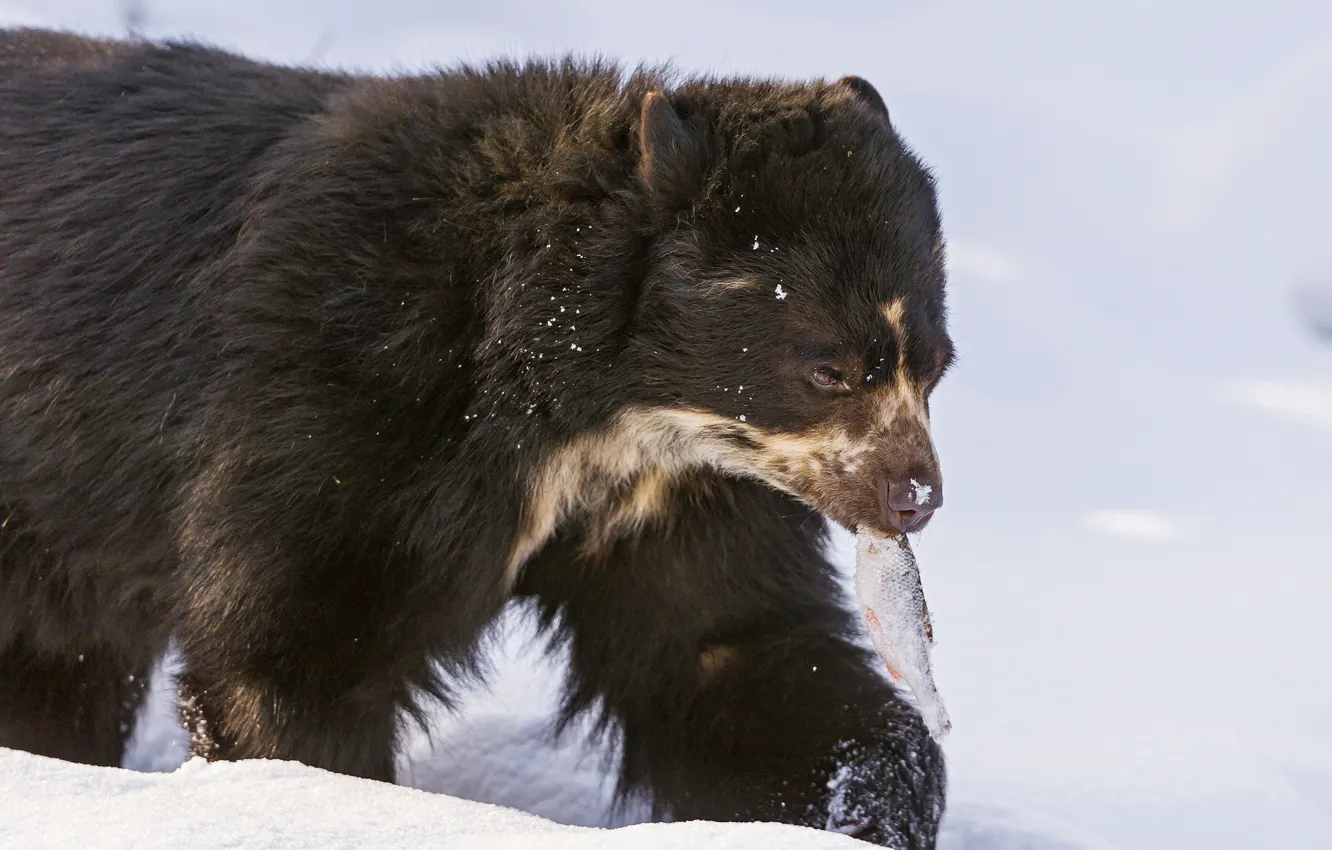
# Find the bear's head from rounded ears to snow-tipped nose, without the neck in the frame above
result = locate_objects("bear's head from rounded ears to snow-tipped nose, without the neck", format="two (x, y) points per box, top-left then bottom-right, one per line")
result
(620, 77), (954, 533)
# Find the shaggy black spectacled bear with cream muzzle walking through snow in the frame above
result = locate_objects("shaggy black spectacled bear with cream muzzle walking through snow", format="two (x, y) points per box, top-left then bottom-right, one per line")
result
(0, 31), (952, 847)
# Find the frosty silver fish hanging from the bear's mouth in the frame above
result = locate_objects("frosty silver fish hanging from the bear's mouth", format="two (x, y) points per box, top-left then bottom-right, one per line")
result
(855, 529), (952, 741)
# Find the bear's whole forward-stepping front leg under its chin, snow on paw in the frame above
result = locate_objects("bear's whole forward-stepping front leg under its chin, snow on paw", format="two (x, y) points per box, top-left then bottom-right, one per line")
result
(519, 477), (944, 850)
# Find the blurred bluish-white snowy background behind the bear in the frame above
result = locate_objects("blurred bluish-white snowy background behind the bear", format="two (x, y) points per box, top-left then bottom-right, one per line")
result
(0, 0), (1332, 850)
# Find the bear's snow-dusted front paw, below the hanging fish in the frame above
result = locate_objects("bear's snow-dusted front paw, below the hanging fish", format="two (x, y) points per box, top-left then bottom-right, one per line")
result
(642, 621), (944, 850)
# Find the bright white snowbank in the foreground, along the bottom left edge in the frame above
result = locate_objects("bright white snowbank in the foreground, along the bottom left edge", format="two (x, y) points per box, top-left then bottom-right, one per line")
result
(0, 750), (855, 850)
